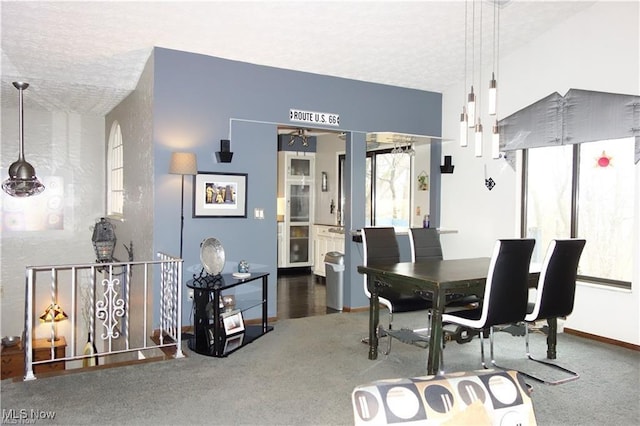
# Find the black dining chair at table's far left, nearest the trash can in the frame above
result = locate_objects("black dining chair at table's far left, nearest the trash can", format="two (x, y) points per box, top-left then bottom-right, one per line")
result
(362, 227), (432, 355)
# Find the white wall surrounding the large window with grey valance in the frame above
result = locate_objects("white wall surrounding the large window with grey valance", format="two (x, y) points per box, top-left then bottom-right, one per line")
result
(441, 2), (640, 345)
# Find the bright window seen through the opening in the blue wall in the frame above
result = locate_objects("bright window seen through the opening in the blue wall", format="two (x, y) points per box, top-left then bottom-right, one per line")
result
(339, 149), (412, 227)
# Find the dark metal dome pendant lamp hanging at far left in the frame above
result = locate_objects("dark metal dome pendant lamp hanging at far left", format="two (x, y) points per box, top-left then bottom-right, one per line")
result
(2, 82), (44, 197)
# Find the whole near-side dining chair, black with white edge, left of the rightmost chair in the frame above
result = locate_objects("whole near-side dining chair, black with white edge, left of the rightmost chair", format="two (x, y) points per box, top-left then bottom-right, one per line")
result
(440, 238), (535, 369)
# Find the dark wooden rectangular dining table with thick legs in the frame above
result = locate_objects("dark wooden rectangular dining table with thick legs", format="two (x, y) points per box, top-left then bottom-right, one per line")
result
(358, 257), (557, 375)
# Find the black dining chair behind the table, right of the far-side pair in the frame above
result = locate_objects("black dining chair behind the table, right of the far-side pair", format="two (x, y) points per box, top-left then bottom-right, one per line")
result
(409, 228), (480, 307)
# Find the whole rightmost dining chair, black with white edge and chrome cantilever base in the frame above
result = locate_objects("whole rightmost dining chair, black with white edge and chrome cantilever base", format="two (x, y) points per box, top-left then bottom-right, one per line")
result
(522, 239), (586, 385)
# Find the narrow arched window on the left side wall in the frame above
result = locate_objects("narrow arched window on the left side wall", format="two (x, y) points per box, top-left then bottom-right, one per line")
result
(107, 122), (124, 217)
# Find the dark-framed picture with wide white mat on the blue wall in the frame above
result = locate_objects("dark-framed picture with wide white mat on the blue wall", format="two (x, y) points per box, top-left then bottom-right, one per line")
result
(193, 172), (247, 218)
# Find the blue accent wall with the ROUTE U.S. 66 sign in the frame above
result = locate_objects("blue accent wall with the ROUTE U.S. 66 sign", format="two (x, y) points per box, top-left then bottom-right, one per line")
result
(153, 48), (442, 324)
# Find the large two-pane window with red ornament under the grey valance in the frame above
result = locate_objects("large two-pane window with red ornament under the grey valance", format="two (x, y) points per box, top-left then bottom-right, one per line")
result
(523, 138), (636, 288)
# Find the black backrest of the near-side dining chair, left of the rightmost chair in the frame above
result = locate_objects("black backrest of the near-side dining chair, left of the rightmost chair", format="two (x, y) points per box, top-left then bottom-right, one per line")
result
(479, 238), (535, 328)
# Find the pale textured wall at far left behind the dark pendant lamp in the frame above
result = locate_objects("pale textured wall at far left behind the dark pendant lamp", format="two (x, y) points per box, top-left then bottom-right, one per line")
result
(0, 108), (105, 337)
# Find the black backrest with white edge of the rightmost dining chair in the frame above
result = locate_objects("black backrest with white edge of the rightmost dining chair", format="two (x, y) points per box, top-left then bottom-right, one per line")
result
(526, 239), (586, 321)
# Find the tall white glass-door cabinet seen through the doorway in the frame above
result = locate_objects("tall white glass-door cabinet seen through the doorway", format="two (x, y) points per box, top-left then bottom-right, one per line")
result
(278, 151), (315, 268)
